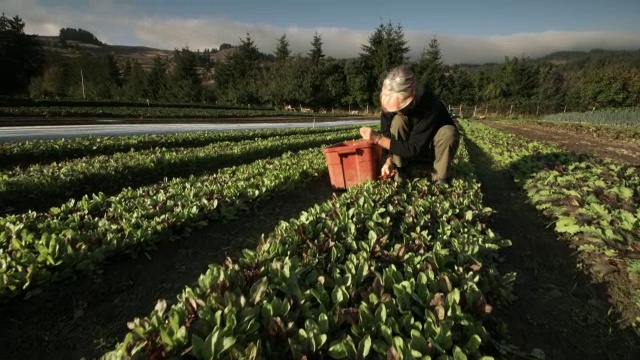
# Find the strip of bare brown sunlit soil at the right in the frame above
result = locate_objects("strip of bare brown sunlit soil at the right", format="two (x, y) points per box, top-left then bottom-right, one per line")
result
(482, 120), (640, 165)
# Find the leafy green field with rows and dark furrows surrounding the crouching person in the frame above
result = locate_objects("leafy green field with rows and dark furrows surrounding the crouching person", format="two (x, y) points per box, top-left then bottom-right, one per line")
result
(0, 124), (640, 359)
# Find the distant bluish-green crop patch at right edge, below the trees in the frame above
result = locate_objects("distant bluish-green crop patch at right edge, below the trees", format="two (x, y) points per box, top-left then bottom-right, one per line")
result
(543, 108), (640, 127)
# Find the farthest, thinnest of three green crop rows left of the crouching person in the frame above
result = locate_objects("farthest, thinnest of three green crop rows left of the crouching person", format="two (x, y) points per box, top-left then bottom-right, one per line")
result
(0, 127), (354, 169)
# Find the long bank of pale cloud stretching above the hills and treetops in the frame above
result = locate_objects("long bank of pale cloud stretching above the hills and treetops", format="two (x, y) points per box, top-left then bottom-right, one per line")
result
(5, 0), (640, 63)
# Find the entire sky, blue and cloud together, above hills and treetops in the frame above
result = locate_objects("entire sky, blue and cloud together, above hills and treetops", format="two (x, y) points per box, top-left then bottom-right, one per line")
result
(0, 0), (640, 64)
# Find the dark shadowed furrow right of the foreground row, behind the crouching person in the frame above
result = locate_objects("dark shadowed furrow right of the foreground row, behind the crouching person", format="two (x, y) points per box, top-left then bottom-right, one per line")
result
(465, 139), (640, 360)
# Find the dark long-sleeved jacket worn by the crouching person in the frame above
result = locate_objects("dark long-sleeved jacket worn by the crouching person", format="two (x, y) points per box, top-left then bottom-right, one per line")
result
(380, 87), (455, 158)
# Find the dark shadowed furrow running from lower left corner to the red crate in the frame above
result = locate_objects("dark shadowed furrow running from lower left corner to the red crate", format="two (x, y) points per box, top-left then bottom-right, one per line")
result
(0, 176), (333, 359)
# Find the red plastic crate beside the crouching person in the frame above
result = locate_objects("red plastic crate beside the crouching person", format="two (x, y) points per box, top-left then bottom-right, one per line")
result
(323, 140), (382, 190)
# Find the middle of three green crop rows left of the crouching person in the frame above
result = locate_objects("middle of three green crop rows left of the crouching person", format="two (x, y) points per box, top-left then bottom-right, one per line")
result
(0, 130), (357, 213)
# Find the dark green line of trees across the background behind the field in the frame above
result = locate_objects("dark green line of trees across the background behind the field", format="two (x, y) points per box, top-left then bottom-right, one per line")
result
(0, 15), (640, 113)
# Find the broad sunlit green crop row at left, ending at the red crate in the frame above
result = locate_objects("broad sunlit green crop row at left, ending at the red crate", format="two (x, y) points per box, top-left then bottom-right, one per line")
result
(0, 142), (356, 296)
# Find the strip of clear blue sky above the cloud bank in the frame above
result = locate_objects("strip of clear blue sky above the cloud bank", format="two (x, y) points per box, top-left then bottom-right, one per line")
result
(110, 0), (640, 35)
